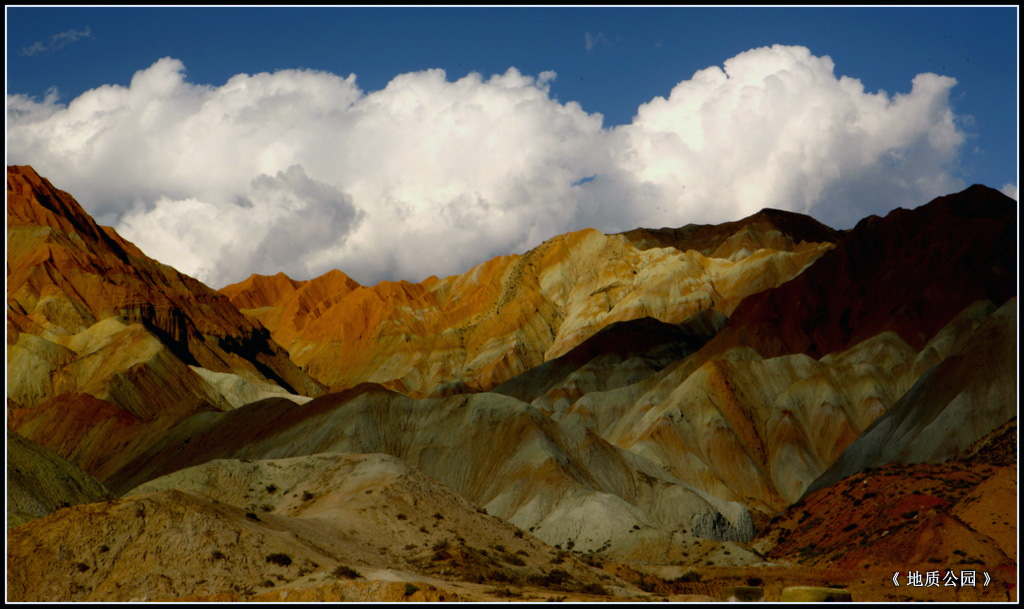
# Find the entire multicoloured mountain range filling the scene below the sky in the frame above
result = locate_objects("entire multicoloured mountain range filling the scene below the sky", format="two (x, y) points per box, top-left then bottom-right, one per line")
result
(7, 167), (1017, 601)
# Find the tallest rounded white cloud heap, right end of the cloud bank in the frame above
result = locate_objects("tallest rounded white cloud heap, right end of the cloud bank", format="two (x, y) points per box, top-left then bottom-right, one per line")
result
(621, 46), (964, 227)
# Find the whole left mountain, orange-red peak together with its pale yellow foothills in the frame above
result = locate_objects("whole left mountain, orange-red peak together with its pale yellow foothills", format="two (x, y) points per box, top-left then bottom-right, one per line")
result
(7, 167), (322, 477)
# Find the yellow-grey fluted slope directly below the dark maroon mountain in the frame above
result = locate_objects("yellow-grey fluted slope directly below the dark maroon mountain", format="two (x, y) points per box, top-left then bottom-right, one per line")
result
(548, 301), (995, 514)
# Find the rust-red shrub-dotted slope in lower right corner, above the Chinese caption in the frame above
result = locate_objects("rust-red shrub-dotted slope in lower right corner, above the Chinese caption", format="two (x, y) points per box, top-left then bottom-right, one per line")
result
(753, 418), (1017, 590)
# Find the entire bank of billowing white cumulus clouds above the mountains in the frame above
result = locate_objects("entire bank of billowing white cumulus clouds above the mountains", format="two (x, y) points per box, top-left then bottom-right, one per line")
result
(7, 46), (964, 287)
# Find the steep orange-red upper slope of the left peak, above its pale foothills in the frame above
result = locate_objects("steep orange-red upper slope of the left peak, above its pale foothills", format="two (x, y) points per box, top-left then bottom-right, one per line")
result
(7, 167), (319, 395)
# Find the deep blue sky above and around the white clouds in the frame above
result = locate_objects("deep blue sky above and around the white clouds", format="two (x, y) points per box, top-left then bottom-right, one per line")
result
(6, 7), (1018, 284)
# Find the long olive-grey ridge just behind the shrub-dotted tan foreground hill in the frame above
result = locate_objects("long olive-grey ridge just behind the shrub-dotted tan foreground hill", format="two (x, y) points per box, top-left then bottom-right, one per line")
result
(111, 387), (753, 561)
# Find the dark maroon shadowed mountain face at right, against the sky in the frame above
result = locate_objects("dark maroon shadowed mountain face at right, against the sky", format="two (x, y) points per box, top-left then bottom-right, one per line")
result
(707, 185), (1017, 357)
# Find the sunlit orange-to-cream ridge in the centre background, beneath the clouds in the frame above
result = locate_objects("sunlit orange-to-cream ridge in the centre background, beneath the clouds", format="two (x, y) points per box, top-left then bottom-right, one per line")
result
(222, 210), (840, 396)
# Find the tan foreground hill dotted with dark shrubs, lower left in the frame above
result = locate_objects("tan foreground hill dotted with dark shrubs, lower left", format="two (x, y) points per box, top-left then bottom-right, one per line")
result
(7, 453), (614, 601)
